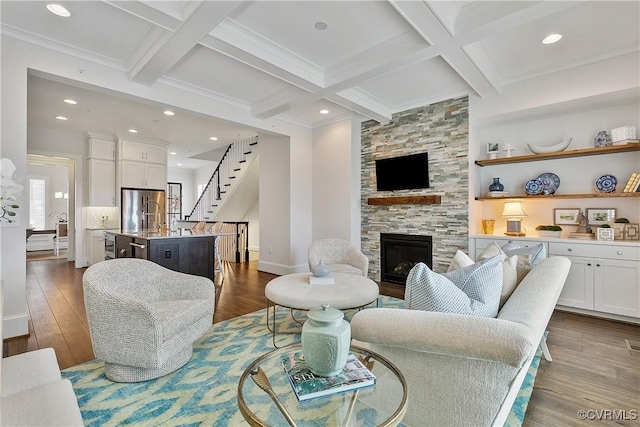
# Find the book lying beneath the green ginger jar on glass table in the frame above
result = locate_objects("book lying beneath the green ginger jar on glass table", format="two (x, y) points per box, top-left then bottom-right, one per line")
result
(282, 350), (376, 402)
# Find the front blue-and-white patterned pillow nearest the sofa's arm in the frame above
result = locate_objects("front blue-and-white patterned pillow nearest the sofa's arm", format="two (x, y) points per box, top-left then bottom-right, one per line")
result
(404, 255), (505, 317)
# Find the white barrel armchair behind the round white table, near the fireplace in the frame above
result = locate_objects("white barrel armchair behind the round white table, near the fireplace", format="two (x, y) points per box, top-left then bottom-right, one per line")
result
(309, 239), (369, 277)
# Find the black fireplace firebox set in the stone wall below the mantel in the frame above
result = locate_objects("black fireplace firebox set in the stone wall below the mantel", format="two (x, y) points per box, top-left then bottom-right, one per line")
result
(380, 233), (433, 285)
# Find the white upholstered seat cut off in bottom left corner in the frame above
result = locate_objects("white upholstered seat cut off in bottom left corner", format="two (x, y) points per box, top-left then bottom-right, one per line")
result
(0, 286), (84, 426)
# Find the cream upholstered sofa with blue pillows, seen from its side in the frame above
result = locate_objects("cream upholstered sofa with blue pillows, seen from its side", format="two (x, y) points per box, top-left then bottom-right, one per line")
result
(351, 257), (571, 427)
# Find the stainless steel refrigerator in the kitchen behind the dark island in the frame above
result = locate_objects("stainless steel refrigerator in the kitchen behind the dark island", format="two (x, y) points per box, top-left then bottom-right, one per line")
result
(120, 188), (166, 232)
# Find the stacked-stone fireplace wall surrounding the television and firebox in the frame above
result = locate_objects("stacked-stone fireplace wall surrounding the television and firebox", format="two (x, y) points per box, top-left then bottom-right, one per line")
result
(360, 96), (469, 284)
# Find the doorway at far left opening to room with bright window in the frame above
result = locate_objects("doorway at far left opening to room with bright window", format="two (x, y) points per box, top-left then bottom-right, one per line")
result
(26, 154), (76, 261)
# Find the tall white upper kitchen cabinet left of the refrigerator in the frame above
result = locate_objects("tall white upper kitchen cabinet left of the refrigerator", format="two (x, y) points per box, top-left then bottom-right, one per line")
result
(86, 133), (116, 207)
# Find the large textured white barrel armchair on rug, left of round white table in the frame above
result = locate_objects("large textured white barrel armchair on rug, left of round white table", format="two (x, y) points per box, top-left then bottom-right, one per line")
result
(82, 258), (215, 382)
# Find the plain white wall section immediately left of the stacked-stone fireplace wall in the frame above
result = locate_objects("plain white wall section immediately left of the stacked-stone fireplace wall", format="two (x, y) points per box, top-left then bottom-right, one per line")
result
(311, 120), (360, 247)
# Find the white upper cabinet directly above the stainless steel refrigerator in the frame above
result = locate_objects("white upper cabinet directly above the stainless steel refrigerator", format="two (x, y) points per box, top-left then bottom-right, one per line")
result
(117, 138), (167, 190)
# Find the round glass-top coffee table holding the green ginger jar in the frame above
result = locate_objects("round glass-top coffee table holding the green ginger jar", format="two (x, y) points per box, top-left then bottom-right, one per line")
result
(237, 342), (407, 427)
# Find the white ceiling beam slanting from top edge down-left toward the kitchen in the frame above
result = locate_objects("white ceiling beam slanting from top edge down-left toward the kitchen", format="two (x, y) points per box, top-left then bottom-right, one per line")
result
(129, 1), (246, 86)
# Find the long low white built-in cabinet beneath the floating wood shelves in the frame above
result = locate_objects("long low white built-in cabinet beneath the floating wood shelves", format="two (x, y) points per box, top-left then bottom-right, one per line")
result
(469, 235), (640, 322)
